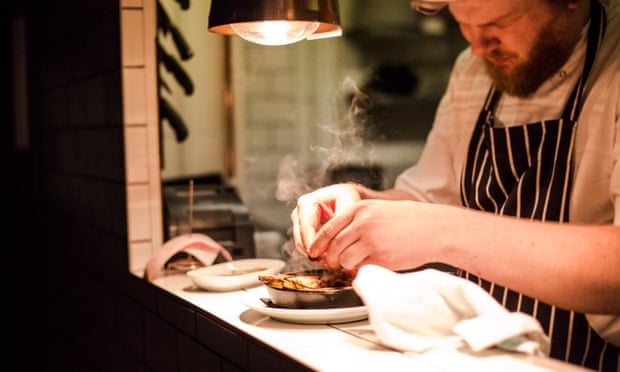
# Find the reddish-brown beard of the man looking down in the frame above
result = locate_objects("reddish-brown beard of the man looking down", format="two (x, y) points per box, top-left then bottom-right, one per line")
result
(484, 23), (576, 98)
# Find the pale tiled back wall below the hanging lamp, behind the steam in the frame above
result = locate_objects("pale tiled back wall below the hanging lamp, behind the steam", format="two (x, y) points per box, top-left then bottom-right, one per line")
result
(232, 38), (378, 231)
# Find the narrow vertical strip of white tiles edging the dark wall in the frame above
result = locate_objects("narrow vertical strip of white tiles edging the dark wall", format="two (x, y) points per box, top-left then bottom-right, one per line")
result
(121, 0), (163, 273)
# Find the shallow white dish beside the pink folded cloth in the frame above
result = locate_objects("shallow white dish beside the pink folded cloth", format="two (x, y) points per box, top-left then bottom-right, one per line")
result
(187, 258), (285, 291)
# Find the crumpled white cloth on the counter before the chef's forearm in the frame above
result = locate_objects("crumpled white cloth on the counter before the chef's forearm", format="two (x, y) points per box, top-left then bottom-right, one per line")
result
(353, 265), (549, 355)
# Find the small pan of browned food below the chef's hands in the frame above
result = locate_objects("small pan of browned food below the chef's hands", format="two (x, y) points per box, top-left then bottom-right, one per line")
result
(258, 269), (363, 309)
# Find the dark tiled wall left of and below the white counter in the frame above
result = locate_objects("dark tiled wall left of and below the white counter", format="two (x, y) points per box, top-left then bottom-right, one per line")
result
(11, 0), (312, 372)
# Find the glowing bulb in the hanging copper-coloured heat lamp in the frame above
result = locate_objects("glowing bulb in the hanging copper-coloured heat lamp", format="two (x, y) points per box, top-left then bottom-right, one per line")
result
(231, 21), (319, 45)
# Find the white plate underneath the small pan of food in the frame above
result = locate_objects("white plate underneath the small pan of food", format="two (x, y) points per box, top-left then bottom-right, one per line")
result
(241, 293), (368, 324)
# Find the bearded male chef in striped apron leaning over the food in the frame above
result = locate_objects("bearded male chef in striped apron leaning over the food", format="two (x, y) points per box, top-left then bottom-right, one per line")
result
(291, 0), (620, 371)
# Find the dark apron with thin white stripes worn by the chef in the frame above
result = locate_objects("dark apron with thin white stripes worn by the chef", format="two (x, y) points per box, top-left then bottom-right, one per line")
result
(461, 1), (620, 372)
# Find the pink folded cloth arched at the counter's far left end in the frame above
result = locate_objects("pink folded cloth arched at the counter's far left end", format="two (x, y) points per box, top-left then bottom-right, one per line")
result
(144, 233), (232, 281)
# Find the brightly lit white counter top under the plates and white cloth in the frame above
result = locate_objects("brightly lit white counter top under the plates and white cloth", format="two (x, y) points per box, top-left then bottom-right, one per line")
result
(153, 274), (584, 371)
